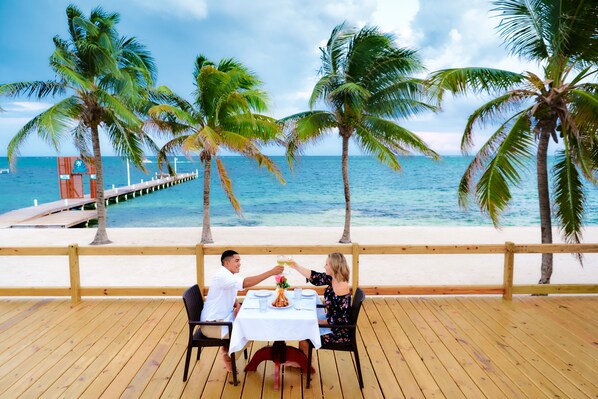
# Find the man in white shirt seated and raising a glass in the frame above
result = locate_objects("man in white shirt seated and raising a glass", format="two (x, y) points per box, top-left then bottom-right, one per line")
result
(200, 249), (284, 372)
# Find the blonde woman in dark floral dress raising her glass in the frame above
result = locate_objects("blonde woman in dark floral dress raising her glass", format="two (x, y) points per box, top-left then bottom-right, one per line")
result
(289, 252), (351, 354)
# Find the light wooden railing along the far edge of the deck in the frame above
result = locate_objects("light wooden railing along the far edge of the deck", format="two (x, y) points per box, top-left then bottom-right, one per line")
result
(0, 242), (598, 304)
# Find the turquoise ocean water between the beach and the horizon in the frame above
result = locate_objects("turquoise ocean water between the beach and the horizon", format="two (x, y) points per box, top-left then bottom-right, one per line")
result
(0, 156), (598, 227)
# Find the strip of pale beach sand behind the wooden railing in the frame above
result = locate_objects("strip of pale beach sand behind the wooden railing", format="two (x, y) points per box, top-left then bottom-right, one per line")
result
(0, 226), (598, 287)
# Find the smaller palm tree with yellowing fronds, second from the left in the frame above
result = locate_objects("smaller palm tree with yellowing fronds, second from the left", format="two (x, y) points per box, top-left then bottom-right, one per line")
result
(150, 55), (284, 243)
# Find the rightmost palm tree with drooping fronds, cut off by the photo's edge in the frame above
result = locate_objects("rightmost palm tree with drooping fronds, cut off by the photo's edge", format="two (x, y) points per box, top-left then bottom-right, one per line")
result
(430, 0), (598, 284)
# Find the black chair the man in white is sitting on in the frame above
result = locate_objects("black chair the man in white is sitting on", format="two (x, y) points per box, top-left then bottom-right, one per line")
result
(183, 284), (247, 385)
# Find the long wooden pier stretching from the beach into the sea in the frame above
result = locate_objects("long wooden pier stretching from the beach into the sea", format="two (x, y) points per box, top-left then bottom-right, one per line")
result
(0, 173), (197, 228)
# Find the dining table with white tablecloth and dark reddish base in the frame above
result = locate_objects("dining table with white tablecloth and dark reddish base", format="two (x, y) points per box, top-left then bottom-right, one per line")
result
(229, 289), (324, 390)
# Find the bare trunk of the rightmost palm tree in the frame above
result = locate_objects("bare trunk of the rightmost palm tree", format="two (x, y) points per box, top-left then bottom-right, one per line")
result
(537, 131), (552, 284)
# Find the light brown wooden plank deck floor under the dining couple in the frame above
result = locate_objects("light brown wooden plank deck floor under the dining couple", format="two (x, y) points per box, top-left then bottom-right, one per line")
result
(0, 296), (598, 399)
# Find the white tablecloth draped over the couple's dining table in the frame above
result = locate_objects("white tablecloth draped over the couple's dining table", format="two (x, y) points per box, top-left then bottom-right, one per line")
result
(229, 291), (323, 353)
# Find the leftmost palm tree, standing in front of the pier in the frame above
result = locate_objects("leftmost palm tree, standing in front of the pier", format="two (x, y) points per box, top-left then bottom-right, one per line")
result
(0, 5), (155, 244)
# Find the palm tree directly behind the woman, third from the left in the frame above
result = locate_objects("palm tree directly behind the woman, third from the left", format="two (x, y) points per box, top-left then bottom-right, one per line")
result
(282, 24), (438, 243)
